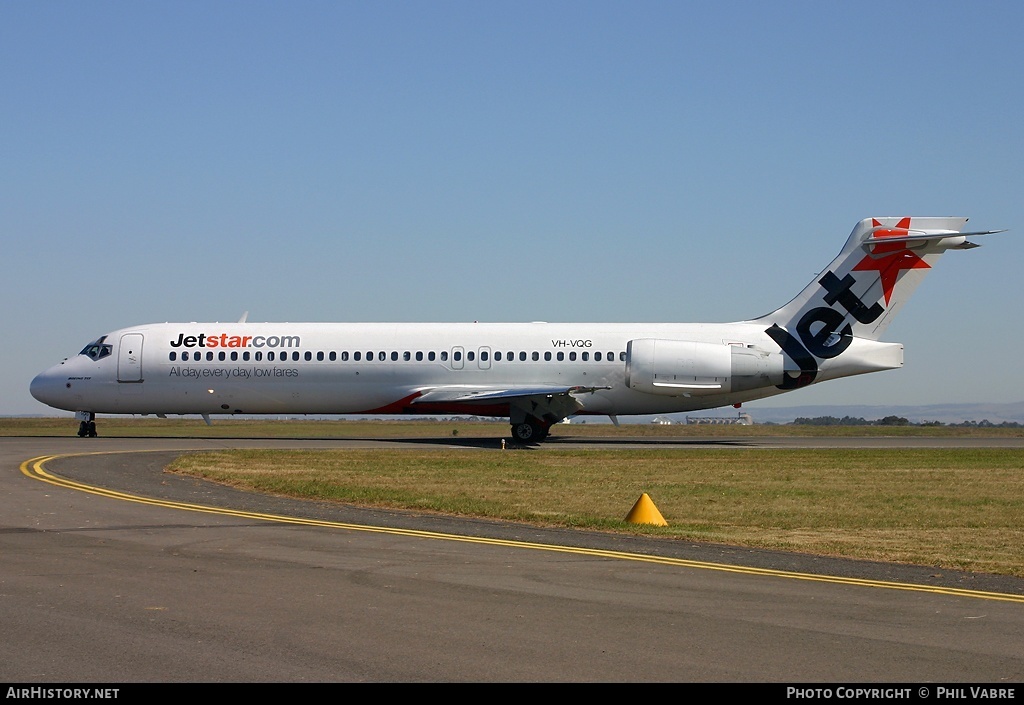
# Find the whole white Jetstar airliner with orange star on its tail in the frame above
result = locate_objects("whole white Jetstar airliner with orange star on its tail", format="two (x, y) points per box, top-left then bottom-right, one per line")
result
(31, 217), (1001, 443)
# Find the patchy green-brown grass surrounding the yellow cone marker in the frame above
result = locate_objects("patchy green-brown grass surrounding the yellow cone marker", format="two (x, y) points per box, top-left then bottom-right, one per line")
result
(169, 448), (1024, 577)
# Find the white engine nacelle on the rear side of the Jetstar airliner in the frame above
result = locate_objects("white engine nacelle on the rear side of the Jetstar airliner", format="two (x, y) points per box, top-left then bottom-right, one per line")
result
(626, 338), (784, 397)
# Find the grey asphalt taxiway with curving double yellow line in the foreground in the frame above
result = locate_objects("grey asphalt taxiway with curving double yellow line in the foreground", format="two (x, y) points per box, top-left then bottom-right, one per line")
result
(0, 438), (1024, 683)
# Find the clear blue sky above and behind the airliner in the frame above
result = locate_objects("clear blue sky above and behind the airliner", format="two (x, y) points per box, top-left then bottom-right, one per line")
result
(0, 0), (1024, 414)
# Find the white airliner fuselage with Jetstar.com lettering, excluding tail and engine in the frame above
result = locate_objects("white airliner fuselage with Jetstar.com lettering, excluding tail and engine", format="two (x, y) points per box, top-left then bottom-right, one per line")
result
(32, 323), (806, 416)
